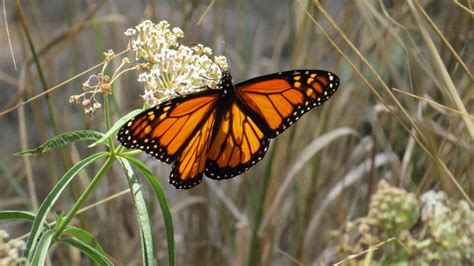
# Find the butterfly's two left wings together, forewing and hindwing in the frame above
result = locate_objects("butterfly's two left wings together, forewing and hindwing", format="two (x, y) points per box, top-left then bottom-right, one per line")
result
(118, 90), (219, 188)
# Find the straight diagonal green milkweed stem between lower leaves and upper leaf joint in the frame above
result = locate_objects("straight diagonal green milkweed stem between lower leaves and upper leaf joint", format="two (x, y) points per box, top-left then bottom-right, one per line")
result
(53, 156), (115, 240)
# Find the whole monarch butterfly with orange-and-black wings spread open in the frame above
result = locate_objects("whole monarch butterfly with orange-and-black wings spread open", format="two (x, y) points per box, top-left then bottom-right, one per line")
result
(118, 69), (339, 189)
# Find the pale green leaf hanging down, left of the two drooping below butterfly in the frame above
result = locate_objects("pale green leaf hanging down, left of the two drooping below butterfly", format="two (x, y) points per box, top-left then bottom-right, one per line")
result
(118, 157), (155, 265)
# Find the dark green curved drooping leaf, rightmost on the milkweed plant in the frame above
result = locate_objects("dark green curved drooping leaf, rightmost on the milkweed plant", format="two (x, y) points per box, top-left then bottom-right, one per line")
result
(124, 156), (176, 266)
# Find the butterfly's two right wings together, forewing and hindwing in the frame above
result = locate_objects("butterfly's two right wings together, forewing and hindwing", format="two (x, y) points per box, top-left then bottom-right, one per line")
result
(206, 70), (339, 179)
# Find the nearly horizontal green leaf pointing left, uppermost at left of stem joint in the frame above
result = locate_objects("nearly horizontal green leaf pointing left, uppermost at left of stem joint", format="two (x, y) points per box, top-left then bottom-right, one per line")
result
(14, 130), (102, 156)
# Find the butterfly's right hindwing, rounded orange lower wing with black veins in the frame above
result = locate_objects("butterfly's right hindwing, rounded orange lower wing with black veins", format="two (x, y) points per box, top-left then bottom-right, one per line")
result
(206, 102), (269, 179)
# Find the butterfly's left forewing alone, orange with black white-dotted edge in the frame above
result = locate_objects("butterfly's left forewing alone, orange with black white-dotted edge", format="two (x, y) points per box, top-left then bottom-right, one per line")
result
(117, 90), (219, 163)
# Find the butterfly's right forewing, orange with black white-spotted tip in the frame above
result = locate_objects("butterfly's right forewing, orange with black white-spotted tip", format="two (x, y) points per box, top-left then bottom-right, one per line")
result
(236, 70), (339, 138)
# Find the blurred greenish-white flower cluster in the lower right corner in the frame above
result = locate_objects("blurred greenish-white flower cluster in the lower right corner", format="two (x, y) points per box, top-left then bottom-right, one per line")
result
(333, 180), (474, 265)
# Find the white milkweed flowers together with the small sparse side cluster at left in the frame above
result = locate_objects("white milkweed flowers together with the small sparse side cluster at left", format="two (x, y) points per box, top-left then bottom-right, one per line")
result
(69, 20), (228, 117)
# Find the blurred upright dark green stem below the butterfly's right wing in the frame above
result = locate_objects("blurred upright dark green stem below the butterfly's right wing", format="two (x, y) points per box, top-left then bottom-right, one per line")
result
(247, 141), (278, 265)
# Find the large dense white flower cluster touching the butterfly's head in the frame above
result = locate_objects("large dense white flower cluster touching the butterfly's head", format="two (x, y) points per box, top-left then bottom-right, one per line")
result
(125, 20), (228, 106)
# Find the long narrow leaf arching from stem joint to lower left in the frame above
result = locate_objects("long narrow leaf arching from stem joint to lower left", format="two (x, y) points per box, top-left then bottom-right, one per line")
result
(25, 152), (108, 260)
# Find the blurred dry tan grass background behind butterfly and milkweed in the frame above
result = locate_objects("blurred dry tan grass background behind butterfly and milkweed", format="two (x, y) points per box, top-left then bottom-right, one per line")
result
(0, 0), (474, 265)
